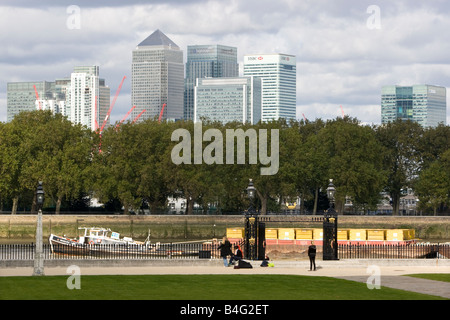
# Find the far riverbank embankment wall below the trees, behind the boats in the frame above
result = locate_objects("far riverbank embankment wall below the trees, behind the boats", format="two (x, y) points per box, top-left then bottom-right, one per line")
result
(0, 213), (450, 242)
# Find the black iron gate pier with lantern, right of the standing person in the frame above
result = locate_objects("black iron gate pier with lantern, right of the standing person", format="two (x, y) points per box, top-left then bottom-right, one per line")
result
(323, 179), (338, 260)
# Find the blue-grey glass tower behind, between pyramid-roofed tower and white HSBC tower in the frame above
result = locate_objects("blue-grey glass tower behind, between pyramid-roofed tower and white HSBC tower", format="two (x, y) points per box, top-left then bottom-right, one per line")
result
(184, 45), (239, 120)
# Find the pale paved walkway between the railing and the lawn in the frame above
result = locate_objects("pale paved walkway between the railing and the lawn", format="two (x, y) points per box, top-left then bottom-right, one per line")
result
(0, 260), (450, 299)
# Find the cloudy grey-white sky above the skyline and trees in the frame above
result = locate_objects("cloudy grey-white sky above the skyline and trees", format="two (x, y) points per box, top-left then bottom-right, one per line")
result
(0, 0), (450, 124)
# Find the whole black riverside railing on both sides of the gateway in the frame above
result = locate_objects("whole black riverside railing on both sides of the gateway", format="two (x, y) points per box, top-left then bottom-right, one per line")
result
(0, 242), (450, 260)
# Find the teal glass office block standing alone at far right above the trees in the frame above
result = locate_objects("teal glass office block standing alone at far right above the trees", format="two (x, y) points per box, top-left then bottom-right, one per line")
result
(381, 85), (447, 127)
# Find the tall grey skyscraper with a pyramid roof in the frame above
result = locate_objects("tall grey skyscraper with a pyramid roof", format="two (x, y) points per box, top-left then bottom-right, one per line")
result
(131, 30), (184, 121)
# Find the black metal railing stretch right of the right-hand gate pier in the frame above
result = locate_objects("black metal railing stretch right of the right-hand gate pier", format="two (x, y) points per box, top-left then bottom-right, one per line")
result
(338, 243), (450, 259)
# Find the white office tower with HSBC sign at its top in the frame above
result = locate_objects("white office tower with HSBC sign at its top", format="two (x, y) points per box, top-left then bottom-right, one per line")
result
(244, 54), (297, 122)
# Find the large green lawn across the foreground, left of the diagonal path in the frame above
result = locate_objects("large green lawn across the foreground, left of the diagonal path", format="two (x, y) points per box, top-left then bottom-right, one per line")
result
(0, 275), (440, 300)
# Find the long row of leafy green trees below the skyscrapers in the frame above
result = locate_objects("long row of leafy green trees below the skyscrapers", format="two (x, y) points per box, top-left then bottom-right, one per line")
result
(0, 111), (450, 214)
